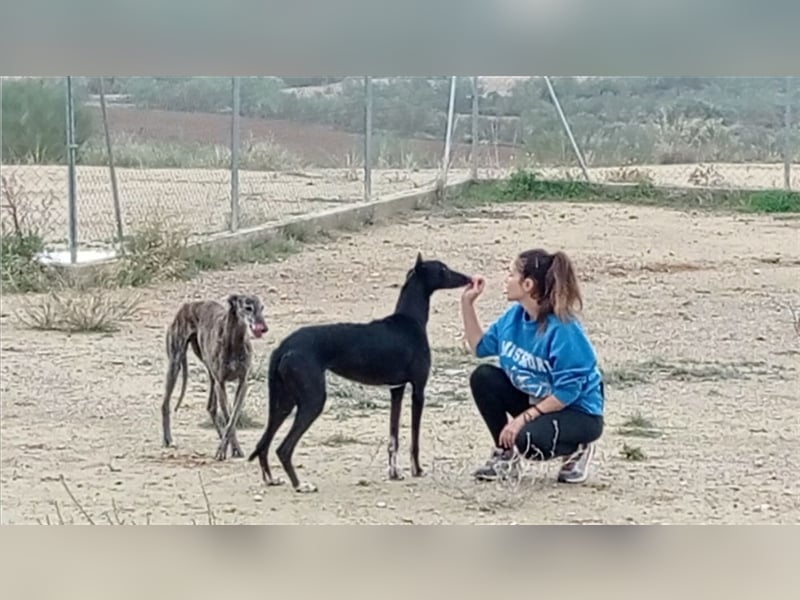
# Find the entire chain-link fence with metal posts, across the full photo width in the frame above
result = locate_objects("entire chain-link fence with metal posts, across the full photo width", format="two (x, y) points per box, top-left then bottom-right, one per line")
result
(0, 76), (800, 260)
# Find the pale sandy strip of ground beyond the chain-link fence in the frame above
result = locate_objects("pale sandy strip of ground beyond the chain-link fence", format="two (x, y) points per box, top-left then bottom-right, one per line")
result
(3, 163), (800, 247)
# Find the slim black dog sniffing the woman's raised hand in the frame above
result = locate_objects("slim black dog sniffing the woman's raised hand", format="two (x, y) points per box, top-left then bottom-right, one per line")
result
(248, 254), (472, 492)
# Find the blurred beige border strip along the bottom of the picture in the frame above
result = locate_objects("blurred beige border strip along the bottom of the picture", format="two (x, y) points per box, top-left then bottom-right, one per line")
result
(0, 525), (800, 599)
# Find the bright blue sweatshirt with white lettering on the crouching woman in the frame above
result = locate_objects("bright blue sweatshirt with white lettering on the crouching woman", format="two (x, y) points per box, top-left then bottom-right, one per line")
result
(475, 302), (604, 415)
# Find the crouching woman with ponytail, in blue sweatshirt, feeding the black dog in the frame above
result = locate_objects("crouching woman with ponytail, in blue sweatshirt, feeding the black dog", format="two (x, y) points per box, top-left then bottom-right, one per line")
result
(461, 249), (605, 483)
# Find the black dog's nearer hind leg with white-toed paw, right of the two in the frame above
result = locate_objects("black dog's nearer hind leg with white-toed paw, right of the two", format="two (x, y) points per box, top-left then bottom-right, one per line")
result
(277, 356), (326, 493)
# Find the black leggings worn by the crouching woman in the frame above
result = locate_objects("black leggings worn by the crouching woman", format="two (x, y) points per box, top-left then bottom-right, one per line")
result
(469, 364), (603, 460)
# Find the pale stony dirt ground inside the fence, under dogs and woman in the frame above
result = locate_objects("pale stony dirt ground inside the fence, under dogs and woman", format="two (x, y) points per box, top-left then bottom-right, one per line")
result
(0, 203), (800, 524)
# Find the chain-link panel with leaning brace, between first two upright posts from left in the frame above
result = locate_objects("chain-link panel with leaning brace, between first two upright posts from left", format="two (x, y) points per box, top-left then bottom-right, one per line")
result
(78, 77), (231, 242)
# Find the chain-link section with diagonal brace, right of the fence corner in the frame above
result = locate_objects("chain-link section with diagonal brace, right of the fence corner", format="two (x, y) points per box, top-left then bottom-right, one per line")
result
(478, 77), (800, 189)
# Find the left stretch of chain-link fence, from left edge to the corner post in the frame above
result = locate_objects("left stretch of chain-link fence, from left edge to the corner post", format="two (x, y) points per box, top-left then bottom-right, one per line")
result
(0, 76), (462, 260)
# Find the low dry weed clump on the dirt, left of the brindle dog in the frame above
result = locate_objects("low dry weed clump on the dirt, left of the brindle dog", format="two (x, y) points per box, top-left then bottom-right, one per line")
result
(17, 288), (139, 333)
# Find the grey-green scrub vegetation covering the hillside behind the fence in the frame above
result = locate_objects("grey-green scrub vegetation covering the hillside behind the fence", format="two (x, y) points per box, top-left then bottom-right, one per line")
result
(3, 77), (800, 166)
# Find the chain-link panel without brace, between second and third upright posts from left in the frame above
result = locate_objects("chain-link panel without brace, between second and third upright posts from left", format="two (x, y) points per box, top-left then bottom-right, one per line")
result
(233, 77), (364, 227)
